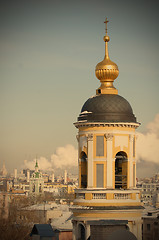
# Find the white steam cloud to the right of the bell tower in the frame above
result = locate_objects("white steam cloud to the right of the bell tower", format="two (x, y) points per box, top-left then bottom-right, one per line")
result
(136, 114), (159, 164)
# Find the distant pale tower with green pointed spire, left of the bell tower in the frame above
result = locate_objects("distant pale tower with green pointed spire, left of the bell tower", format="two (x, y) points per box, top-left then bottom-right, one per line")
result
(29, 160), (44, 194)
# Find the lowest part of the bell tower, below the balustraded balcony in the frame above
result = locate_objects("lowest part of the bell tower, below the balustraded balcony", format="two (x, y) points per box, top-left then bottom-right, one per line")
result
(71, 206), (143, 240)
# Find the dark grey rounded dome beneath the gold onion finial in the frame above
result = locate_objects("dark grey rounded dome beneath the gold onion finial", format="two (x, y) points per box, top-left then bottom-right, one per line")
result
(78, 94), (136, 123)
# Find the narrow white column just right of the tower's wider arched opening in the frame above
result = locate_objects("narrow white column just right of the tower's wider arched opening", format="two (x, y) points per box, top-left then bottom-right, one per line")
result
(128, 135), (134, 188)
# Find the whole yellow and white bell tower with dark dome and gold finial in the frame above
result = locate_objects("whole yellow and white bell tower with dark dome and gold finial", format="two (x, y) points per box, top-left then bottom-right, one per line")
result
(71, 18), (143, 240)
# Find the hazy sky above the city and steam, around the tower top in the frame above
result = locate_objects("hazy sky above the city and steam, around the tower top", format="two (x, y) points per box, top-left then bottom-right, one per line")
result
(0, 0), (159, 170)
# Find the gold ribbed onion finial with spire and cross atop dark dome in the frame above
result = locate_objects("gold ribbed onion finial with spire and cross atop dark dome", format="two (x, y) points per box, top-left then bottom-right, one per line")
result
(95, 18), (119, 94)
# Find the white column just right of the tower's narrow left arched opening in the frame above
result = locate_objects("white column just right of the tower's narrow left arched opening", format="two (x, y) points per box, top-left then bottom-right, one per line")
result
(87, 134), (93, 188)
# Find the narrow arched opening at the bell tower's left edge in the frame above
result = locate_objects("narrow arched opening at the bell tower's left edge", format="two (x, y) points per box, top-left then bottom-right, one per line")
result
(80, 152), (87, 188)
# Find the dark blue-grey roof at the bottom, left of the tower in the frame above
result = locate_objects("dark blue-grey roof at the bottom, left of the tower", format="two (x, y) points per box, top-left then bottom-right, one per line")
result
(30, 224), (55, 237)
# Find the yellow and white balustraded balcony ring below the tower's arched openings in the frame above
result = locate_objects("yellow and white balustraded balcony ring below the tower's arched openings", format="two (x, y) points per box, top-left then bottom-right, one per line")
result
(74, 188), (141, 206)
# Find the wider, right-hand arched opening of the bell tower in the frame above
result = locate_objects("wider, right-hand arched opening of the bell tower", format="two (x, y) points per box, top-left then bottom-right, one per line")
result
(115, 151), (128, 189)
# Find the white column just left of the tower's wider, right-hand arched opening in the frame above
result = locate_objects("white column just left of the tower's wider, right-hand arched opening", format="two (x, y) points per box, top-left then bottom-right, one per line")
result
(105, 133), (113, 189)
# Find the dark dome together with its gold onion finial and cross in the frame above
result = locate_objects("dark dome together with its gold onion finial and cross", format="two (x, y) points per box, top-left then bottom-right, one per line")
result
(75, 18), (137, 124)
